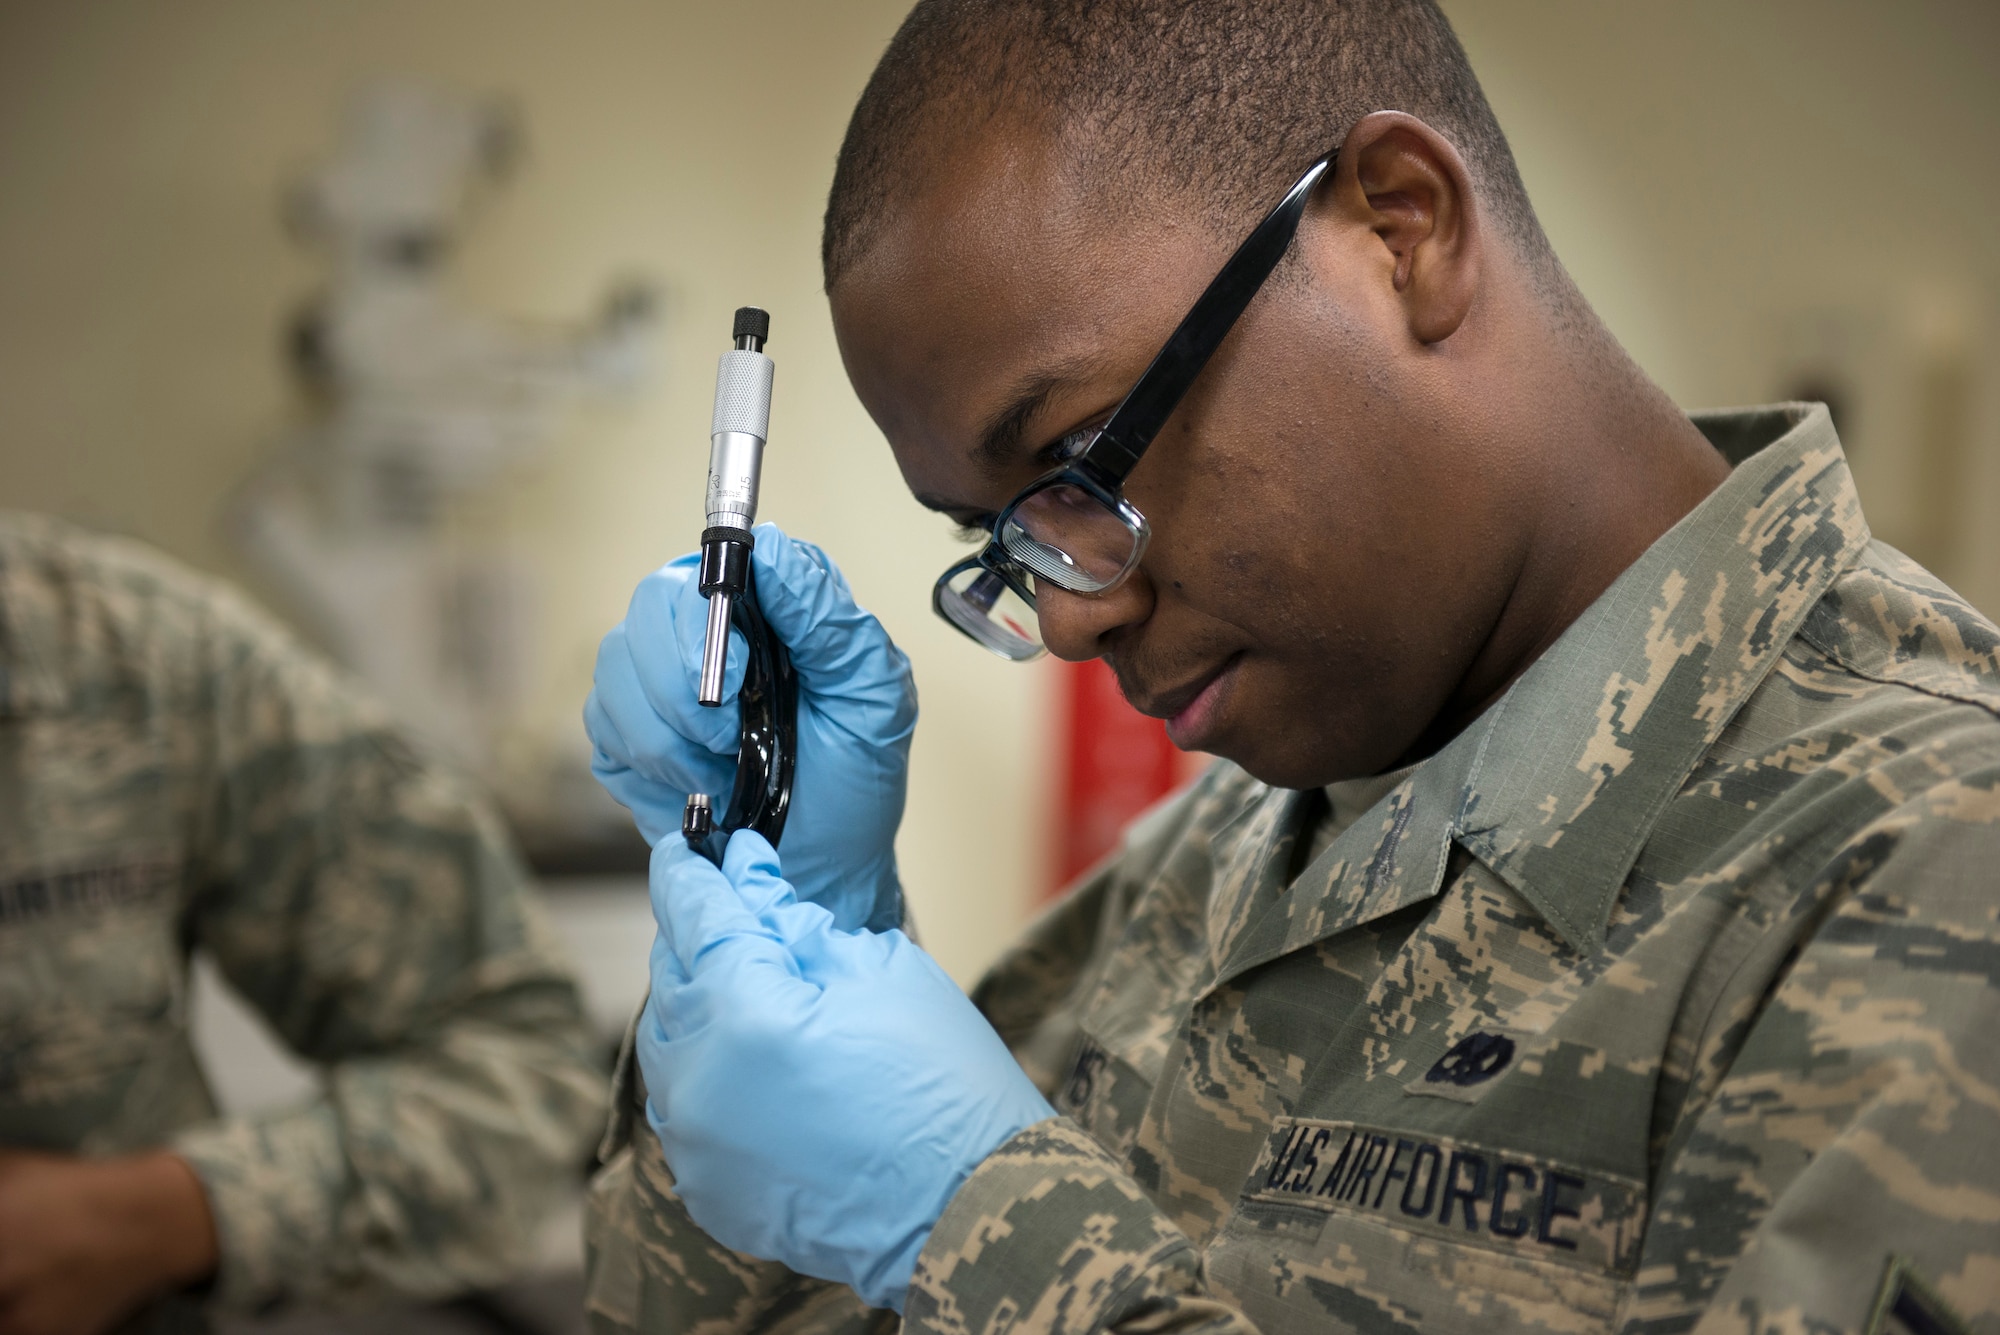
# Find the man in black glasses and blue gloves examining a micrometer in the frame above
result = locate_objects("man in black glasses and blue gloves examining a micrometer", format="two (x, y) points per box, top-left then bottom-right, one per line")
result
(588, 0), (2000, 1335)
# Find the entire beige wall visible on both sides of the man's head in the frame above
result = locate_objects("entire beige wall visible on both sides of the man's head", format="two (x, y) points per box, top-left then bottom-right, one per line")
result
(0, 0), (2000, 977)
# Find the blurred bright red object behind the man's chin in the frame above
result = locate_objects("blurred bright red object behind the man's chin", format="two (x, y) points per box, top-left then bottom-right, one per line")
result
(1048, 660), (1206, 895)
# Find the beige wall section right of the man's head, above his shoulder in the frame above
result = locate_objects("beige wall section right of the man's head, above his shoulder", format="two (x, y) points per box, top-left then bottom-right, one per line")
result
(1444, 0), (2000, 614)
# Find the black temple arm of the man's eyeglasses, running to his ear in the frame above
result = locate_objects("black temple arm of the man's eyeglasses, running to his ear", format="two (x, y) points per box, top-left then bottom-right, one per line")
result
(1078, 154), (1334, 484)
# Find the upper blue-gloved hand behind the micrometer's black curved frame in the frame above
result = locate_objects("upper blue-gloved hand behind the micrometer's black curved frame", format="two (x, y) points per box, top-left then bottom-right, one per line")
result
(584, 524), (916, 931)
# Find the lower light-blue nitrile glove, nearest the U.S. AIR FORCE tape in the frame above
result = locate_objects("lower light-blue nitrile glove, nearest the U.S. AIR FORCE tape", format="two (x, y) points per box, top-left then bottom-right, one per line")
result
(638, 829), (1056, 1311)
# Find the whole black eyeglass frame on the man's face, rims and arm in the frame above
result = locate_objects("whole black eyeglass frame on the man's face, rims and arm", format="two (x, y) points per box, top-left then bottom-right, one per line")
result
(930, 150), (1338, 662)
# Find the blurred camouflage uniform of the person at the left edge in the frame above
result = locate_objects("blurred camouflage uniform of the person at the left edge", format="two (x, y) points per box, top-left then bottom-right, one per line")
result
(0, 516), (604, 1323)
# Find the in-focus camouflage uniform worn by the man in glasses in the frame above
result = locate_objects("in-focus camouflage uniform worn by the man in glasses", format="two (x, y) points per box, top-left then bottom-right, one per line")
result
(588, 406), (2000, 1335)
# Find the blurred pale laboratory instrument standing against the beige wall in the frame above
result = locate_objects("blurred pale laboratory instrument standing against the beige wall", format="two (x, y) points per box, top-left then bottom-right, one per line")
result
(226, 82), (658, 869)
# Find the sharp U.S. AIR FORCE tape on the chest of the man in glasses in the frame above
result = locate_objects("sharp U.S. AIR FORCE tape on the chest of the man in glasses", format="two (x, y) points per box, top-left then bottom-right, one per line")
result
(1244, 1117), (1646, 1271)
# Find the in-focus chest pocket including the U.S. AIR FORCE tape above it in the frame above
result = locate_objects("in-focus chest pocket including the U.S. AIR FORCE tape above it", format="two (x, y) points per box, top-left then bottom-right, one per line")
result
(1208, 1117), (1646, 1335)
